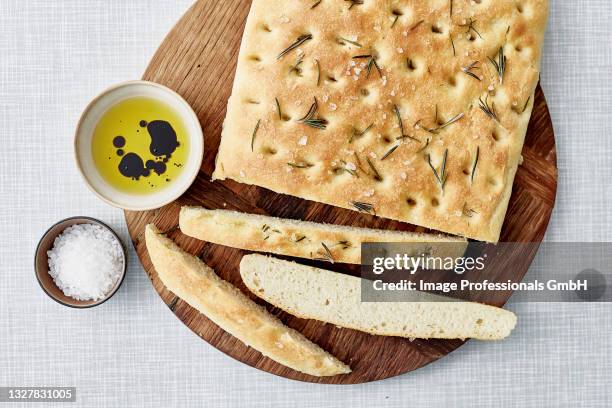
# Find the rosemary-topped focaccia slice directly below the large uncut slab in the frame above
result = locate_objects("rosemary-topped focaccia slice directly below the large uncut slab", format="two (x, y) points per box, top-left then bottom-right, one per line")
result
(179, 207), (467, 264)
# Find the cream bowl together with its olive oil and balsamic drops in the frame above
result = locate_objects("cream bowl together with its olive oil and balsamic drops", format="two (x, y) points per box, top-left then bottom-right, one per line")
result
(74, 81), (204, 211)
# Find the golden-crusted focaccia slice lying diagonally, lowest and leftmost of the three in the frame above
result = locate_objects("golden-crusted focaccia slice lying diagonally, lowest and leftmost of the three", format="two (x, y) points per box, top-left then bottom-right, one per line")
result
(145, 225), (351, 376)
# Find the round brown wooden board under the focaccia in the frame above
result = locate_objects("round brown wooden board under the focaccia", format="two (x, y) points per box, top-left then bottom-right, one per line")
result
(125, 0), (557, 384)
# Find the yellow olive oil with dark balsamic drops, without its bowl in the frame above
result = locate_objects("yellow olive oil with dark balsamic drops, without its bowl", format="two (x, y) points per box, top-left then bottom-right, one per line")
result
(91, 97), (189, 194)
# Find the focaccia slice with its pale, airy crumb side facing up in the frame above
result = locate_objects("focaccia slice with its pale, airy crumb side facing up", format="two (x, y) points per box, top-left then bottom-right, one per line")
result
(240, 255), (516, 340)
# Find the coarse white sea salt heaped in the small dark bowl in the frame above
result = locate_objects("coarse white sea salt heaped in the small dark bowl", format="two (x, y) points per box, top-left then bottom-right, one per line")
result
(47, 224), (124, 300)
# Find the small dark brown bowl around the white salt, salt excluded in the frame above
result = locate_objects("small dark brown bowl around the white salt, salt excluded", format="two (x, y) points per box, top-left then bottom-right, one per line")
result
(34, 217), (127, 309)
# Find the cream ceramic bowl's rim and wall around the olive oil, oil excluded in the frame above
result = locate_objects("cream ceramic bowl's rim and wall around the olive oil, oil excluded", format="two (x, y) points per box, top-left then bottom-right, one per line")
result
(74, 81), (204, 211)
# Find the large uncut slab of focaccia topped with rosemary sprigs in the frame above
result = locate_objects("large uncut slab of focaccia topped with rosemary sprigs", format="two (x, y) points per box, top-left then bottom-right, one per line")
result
(213, 0), (548, 242)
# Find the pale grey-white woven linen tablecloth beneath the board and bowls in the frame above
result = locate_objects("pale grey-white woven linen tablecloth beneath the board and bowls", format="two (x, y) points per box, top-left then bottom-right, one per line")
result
(0, 0), (612, 408)
